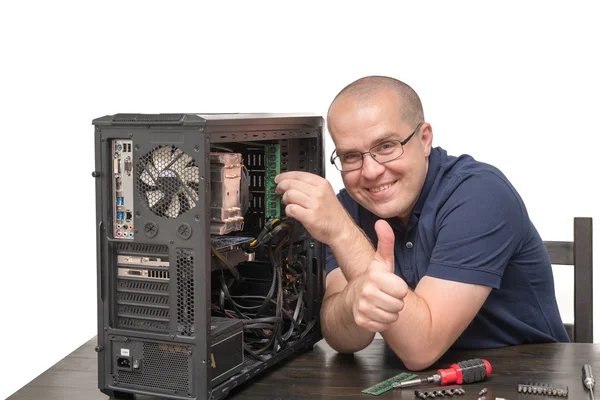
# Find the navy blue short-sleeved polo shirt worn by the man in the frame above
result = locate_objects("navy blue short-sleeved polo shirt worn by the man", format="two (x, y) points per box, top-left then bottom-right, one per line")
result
(326, 147), (569, 348)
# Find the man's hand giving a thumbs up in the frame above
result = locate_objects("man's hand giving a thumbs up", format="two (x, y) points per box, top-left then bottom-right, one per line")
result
(348, 220), (408, 332)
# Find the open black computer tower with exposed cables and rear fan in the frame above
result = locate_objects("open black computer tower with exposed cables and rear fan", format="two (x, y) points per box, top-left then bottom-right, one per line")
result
(92, 114), (325, 400)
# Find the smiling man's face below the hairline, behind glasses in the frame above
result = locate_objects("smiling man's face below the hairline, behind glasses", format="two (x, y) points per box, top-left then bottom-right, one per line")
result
(328, 91), (432, 221)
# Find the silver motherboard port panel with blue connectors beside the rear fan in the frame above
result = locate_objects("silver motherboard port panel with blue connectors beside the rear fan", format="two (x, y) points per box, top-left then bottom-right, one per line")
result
(112, 140), (134, 239)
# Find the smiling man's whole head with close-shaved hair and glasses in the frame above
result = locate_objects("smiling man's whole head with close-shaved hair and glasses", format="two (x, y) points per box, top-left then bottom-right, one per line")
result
(327, 76), (433, 220)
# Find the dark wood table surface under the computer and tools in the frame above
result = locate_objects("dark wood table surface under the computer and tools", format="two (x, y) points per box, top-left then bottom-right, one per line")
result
(9, 338), (600, 400)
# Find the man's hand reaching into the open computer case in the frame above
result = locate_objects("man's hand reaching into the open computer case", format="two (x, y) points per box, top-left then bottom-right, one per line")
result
(275, 171), (351, 245)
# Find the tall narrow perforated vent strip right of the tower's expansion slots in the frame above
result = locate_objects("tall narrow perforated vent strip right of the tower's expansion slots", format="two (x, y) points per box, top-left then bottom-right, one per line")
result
(177, 249), (194, 336)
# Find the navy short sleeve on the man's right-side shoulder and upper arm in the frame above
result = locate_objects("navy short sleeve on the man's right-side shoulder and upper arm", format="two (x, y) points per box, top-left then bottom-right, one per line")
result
(427, 171), (525, 289)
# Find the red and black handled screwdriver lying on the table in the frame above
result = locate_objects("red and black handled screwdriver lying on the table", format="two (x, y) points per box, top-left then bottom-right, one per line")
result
(394, 358), (492, 388)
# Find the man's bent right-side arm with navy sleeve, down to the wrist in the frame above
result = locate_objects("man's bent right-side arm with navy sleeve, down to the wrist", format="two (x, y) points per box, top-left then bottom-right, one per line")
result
(382, 171), (525, 370)
